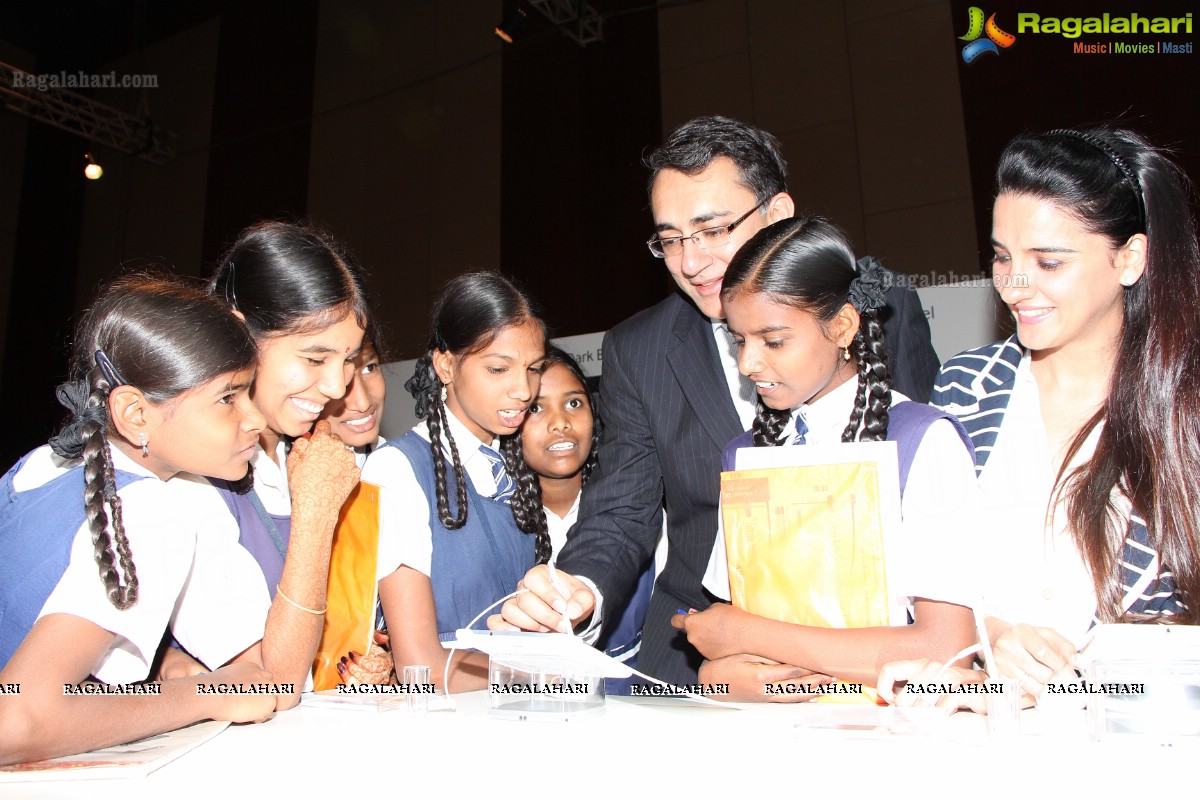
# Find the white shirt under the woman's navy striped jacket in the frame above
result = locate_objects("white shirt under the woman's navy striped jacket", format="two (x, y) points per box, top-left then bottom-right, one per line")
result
(974, 350), (1099, 644)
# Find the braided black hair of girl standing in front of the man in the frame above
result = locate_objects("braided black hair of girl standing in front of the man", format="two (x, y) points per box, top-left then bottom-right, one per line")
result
(721, 217), (892, 447)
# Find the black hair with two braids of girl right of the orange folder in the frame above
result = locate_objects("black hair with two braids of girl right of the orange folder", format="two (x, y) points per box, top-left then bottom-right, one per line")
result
(404, 272), (550, 558)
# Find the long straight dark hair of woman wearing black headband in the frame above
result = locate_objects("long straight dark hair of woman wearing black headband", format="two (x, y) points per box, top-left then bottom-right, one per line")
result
(996, 127), (1200, 622)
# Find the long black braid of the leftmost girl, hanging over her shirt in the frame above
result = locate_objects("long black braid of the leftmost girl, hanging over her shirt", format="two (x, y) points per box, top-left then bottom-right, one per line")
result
(82, 368), (138, 610)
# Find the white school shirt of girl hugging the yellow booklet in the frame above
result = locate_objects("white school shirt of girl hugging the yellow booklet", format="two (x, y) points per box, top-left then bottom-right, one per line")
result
(704, 378), (980, 619)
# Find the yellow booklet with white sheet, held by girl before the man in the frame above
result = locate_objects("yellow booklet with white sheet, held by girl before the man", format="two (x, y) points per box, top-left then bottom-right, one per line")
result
(721, 441), (907, 705)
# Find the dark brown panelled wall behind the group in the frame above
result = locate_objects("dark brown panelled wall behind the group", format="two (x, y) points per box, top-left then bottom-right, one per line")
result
(0, 0), (1200, 463)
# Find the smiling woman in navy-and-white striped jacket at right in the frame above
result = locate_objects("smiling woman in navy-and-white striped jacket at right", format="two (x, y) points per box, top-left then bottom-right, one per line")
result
(878, 127), (1200, 704)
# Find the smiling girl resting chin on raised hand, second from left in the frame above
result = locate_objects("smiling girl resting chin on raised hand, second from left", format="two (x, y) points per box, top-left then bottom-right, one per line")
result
(198, 222), (371, 703)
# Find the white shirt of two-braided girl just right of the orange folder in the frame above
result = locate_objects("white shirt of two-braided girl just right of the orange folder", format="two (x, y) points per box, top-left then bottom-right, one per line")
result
(362, 408), (500, 581)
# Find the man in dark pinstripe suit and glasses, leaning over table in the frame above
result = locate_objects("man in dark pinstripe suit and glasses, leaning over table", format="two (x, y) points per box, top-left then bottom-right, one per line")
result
(493, 116), (938, 685)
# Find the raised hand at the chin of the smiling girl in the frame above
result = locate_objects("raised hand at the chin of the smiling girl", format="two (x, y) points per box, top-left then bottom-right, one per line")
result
(288, 420), (359, 527)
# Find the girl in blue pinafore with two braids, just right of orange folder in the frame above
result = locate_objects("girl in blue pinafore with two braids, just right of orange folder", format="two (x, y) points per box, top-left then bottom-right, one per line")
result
(362, 272), (550, 691)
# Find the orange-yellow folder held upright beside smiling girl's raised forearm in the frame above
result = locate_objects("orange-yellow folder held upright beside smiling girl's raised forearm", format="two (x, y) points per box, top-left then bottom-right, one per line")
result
(312, 483), (379, 692)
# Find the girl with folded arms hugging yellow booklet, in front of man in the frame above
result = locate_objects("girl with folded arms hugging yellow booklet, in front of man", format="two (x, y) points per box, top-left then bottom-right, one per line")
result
(673, 217), (974, 700)
